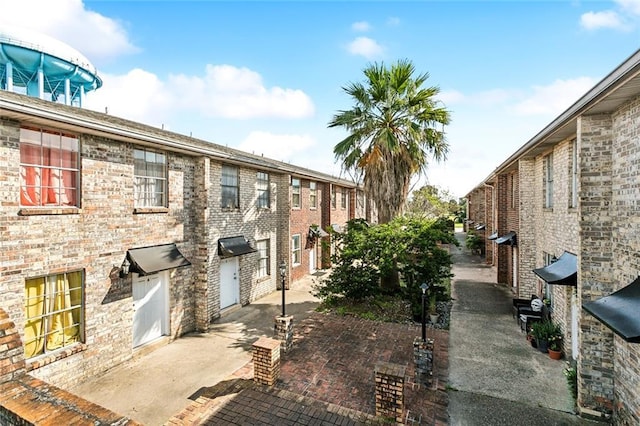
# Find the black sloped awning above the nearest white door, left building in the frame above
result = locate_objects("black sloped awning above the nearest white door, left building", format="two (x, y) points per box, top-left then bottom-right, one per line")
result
(127, 243), (191, 275)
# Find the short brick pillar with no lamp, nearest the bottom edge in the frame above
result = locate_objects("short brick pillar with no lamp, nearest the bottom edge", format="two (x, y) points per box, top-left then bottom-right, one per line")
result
(375, 362), (405, 423)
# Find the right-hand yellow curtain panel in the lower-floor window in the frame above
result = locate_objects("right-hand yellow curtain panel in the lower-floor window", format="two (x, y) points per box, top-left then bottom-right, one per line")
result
(47, 272), (81, 350)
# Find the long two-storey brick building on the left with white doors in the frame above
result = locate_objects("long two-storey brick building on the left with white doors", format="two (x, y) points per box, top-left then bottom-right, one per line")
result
(0, 91), (366, 387)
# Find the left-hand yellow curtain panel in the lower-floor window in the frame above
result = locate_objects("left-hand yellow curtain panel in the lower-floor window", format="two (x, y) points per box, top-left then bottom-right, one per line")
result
(24, 278), (45, 358)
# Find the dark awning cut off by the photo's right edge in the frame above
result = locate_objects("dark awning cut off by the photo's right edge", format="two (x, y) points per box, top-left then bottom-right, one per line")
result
(582, 277), (640, 343)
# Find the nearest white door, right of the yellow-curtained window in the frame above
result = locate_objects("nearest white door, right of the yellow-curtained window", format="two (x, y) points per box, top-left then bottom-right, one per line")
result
(132, 272), (169, 348)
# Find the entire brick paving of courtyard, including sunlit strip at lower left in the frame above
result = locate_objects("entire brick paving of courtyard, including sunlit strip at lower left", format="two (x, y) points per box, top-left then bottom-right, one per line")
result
(167, 313), (449, 426)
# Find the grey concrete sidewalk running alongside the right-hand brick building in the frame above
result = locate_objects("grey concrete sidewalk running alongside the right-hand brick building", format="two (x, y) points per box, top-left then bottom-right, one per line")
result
(449, 233), (594, 426)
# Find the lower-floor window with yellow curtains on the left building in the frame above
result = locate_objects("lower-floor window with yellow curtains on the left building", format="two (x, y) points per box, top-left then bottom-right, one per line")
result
(24, 271), (84, 359)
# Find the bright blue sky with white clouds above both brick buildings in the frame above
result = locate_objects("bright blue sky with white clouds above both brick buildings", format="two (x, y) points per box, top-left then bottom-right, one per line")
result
(0, 0), (640, 197)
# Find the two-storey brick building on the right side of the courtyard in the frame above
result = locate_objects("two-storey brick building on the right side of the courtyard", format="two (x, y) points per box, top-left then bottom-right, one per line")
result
(467, 51), (640, 425)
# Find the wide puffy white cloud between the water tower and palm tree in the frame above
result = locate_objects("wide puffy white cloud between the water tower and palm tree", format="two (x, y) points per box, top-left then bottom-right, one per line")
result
(168, 65), (315, 119)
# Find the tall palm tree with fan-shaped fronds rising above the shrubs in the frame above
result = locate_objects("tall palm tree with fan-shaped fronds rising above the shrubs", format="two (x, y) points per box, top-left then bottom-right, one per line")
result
(328, 60), (450, 223)
